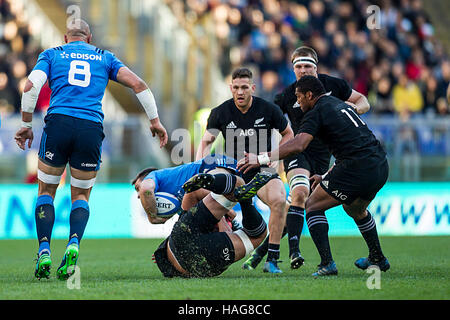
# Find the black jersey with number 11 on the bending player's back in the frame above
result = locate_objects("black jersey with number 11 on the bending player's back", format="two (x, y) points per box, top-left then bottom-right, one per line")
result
(300, 95), (386, 162)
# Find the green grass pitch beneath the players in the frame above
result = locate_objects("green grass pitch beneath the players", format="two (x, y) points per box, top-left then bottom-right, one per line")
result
(0, 236), (450, 300)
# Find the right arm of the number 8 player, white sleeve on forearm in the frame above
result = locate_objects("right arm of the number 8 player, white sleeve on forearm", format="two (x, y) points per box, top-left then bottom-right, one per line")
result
(117, 67), (168, 148)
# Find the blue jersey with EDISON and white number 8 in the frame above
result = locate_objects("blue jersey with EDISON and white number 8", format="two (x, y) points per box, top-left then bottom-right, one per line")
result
(34, 41), (125, 122)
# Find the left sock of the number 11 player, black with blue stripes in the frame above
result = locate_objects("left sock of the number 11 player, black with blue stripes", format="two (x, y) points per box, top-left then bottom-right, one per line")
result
(306, 210), (333, 266)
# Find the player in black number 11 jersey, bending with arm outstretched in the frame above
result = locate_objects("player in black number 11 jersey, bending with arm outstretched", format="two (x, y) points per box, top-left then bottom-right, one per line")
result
(238, 76), (390, 276)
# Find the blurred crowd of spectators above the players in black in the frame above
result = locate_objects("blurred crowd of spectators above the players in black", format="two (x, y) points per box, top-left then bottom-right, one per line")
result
(166, 0), (450, 116)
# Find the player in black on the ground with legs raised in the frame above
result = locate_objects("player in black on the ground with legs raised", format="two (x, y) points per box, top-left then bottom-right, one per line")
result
(153, 172), (278, 277)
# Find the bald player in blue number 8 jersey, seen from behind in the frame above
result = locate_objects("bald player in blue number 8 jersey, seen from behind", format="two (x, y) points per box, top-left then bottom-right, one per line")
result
(15, 19), (168, 280)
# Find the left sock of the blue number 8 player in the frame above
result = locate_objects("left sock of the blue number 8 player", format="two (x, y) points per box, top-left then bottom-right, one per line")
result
(34, 195), (55, 255)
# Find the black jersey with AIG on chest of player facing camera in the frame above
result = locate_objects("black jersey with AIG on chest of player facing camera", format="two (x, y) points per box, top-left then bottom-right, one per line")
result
(206, 96), (288, 160)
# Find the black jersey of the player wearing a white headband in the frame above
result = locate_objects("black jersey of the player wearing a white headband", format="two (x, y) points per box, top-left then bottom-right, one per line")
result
(274, 73), (352, 162)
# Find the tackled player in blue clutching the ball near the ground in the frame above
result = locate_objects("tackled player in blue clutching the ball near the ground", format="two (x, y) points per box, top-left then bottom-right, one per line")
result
(131, 155), (239, 224)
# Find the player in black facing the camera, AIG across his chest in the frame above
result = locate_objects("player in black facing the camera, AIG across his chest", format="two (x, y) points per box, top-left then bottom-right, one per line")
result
(196, 68), (294, 273)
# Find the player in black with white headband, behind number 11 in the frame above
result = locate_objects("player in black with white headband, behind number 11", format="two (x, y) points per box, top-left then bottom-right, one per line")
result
(243, 46), (370, 269)
